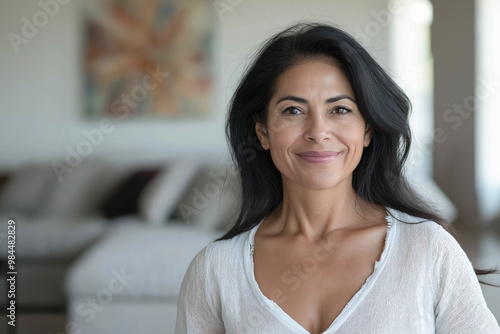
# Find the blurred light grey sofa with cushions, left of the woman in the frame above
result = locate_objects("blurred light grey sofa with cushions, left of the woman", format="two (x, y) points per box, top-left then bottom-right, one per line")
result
(0, 152), (238, 334)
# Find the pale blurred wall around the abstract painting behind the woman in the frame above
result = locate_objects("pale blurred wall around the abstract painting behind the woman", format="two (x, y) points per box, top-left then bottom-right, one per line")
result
(0, 0), (389, 169)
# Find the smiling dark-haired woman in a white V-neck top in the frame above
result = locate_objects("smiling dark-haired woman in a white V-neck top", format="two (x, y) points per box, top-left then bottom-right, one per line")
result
(176, 24), (500, 334)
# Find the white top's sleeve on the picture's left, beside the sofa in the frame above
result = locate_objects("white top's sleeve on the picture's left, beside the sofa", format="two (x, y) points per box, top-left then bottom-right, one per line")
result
(175, 245), (225, 334)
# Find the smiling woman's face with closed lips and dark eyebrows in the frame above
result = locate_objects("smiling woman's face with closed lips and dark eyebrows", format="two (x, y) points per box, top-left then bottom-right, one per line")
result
(255, 60), (372, 189)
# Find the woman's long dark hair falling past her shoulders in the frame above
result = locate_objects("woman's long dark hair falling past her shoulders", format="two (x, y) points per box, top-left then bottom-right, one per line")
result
(215, 23), (498, 285)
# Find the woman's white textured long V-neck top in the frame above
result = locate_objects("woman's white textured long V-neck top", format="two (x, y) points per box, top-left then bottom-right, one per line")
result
(176, 208), (500, 334)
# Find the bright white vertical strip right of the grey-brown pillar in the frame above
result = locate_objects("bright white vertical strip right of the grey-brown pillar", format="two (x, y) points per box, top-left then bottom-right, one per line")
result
(474, 0), (500, 224)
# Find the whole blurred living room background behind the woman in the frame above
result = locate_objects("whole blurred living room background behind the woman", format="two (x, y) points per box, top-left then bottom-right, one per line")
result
(0, 0), (500, 334)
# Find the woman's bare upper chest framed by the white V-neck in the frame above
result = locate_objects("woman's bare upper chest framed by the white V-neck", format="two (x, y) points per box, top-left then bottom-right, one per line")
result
(254, 228), (385, 333)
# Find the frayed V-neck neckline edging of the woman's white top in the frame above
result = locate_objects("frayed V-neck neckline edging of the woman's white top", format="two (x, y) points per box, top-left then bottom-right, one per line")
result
(244, 207), (397, 334)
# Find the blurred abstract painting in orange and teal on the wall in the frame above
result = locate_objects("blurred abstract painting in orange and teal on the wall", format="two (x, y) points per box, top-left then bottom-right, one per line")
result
(83, 0), (215, 120)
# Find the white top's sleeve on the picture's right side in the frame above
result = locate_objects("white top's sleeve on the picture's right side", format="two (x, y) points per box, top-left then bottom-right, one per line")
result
(431, 225), (500, 334)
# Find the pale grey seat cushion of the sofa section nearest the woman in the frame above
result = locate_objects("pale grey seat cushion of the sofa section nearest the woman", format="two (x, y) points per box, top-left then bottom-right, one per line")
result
(65, 217), (220, 298)
